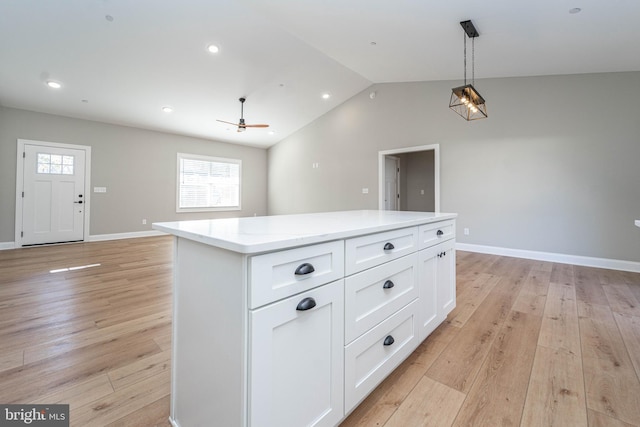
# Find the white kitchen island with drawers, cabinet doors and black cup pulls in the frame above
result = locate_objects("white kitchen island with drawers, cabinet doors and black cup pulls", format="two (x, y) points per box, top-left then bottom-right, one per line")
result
(153, 211), (456, 427)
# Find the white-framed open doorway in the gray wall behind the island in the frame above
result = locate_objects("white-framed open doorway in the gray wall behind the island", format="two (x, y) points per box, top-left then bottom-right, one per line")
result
(378, 144), (440, 212)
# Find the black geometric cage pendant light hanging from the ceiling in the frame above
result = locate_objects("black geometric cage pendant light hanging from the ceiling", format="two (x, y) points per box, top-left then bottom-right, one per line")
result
(449, 20), (487, 121)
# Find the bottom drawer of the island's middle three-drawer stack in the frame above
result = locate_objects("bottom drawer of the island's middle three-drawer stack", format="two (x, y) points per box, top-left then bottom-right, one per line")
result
(344, 301), (420, 413)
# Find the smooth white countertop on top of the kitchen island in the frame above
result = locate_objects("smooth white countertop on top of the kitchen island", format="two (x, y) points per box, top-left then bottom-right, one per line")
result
(153, 211), (457, 254)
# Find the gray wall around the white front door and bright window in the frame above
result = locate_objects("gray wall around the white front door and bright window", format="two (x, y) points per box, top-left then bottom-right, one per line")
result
(0, 107), (267, 242)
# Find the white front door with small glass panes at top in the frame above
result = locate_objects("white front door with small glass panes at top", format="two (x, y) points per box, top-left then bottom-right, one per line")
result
(22, 144), (86, 245)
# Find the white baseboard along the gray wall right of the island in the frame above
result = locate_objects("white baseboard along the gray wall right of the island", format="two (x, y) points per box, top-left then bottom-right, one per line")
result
(456, 243), (640, 273)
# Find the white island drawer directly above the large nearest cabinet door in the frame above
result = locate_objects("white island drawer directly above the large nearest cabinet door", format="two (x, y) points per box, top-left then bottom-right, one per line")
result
(249, 240), (344, 309)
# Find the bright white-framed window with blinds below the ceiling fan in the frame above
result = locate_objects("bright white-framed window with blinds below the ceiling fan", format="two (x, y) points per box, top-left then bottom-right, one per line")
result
(177, 153), (242, 212)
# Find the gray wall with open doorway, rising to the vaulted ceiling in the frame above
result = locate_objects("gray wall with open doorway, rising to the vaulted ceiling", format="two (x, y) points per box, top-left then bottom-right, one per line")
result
(268, 72), (640, 261)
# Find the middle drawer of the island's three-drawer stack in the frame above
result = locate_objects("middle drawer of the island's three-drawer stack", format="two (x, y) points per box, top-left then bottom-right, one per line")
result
(344, 252), (419, 343)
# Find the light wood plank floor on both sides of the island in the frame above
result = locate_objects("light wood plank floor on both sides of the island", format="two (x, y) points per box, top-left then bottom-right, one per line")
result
(0, 237), (640, 427)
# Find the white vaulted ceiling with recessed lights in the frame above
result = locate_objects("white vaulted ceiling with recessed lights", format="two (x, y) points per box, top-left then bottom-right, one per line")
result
(0, 0), (640, 147)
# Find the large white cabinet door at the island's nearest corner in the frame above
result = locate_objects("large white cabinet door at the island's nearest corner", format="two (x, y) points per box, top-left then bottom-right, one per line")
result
(249, 280), (344, 427)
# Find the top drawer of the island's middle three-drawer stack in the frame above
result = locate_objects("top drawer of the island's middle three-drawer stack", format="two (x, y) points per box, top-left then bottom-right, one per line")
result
(345, 227), (418, 275)
